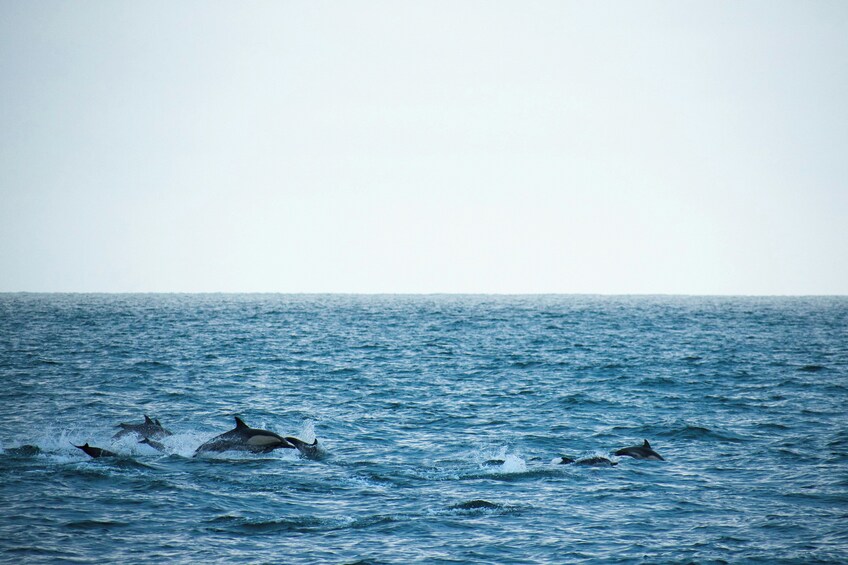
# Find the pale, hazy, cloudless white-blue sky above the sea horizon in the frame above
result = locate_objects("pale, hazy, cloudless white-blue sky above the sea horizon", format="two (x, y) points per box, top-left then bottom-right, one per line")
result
(0, 0), (848, 295)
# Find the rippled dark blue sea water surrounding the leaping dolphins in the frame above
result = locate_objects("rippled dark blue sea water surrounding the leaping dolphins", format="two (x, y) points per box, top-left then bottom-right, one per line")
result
(0, 294), (848, 563)
